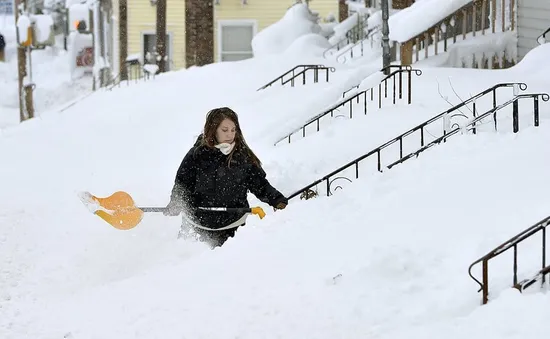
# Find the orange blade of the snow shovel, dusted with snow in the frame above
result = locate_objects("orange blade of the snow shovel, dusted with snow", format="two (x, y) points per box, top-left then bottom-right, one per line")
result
(83, 191), (143, 230)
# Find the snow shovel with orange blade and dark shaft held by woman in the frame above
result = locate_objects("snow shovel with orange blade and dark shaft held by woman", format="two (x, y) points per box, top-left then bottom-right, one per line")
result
(79, 191), (265, 230)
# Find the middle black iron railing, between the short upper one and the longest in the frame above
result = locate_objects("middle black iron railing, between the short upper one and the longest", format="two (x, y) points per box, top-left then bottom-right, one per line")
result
(275, 65), (422, 145)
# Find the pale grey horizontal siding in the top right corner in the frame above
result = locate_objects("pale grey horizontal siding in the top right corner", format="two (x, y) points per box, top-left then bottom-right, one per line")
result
(518, 0), (550, 60)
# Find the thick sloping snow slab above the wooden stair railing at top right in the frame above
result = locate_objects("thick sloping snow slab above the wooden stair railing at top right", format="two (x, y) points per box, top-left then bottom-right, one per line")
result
(389, 0), (472, 42)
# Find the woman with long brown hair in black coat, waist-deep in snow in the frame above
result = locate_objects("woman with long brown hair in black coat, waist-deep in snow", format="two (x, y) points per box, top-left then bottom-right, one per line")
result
(165, 107), (288, 247)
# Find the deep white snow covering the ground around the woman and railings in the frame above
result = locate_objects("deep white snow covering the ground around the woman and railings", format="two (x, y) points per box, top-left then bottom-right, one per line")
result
(0, 4), (550, 339)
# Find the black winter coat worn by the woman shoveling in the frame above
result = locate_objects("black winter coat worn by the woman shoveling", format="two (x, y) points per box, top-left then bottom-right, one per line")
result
(171, 138), (288, 229)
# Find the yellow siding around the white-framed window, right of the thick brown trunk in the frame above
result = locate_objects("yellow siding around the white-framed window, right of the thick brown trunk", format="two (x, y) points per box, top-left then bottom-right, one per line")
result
(214, 0), (338, 62)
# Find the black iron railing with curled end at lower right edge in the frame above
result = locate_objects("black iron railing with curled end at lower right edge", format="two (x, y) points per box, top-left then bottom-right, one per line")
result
(468, 217), (550, 304)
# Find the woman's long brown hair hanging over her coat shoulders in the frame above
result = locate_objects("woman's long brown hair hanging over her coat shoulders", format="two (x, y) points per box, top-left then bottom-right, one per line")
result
(201, 107), (262, 167)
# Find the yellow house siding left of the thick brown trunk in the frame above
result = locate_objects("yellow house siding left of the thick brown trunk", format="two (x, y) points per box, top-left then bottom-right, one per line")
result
(128, 0), (185, 70)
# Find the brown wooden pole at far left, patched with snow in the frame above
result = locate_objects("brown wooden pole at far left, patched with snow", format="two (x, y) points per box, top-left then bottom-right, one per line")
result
(15, 0), (34, 122)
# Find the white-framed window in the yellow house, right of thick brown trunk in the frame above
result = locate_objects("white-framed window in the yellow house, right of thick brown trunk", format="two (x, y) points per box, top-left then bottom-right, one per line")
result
(218, 20), (256, 61)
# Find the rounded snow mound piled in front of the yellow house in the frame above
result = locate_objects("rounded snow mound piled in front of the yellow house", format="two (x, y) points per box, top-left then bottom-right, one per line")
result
(252, 4), (322, 57)
